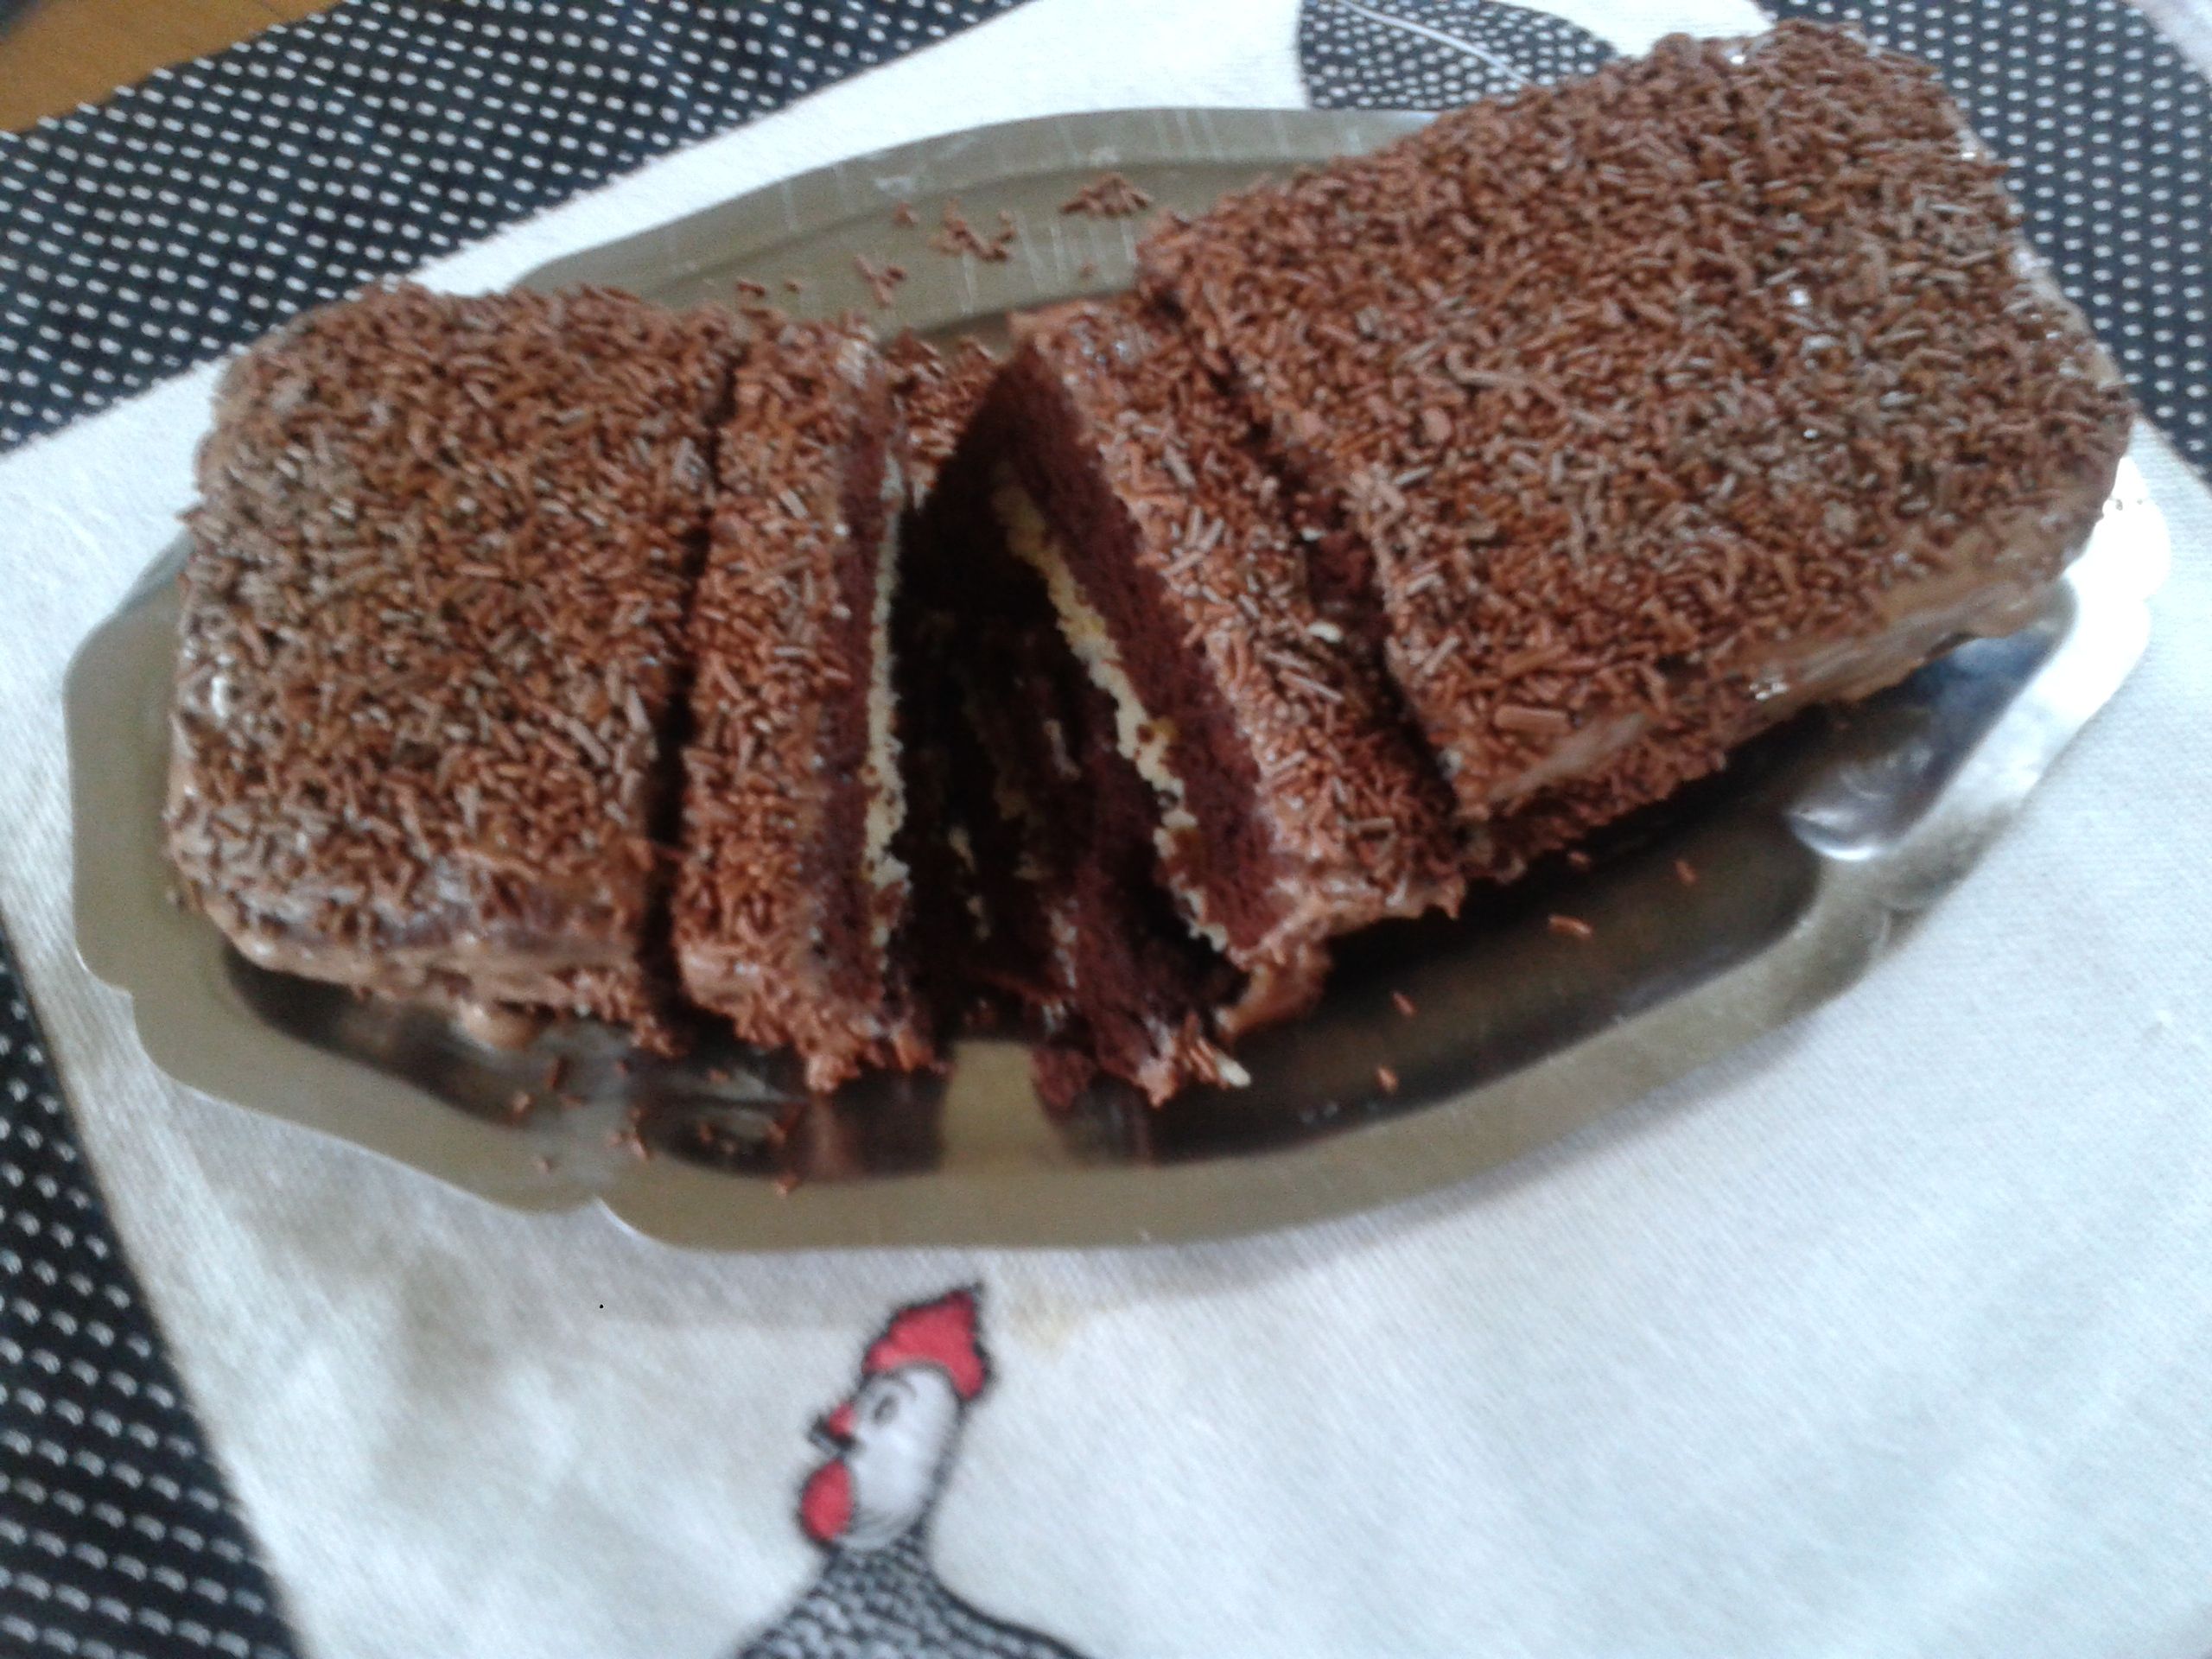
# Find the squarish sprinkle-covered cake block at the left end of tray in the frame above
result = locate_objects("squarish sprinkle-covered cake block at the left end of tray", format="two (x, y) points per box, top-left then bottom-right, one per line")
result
(166, 288), (732, 1038)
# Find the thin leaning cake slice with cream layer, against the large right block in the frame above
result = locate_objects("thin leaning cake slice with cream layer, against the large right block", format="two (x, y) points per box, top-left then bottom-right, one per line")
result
(973, 301), (1460, 1033)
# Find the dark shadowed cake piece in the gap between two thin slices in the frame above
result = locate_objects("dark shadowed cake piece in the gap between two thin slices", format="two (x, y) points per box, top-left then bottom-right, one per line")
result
(892, 343), (1243, 1103)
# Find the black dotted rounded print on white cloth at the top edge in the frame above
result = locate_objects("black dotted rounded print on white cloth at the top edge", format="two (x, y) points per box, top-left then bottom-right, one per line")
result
(1299, 0), (1612, 108)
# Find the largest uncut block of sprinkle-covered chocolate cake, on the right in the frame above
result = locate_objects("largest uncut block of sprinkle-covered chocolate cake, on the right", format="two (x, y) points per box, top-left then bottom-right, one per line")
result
(1141, 24), (2128, 874)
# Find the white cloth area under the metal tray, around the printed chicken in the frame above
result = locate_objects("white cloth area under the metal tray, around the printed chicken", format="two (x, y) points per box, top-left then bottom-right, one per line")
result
(0, 0), (2212, 1659)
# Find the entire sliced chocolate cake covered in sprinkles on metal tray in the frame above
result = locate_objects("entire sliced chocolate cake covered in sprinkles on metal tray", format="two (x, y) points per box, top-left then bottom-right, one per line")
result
(166, 24), (2130, 1119)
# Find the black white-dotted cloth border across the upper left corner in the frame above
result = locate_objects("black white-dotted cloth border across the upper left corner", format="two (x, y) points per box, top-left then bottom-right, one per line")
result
(0, 0), (1018, 449)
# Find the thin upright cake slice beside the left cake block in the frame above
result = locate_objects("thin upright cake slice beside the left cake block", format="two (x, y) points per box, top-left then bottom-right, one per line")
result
(672, 312), (931, 1090)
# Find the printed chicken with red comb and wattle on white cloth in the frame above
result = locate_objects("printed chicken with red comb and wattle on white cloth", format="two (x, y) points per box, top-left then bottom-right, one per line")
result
(741, 1289), (1077, 1659)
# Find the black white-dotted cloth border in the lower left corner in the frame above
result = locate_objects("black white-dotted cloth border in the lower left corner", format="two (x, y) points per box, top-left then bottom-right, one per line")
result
(0, 936), (294, 1659)
